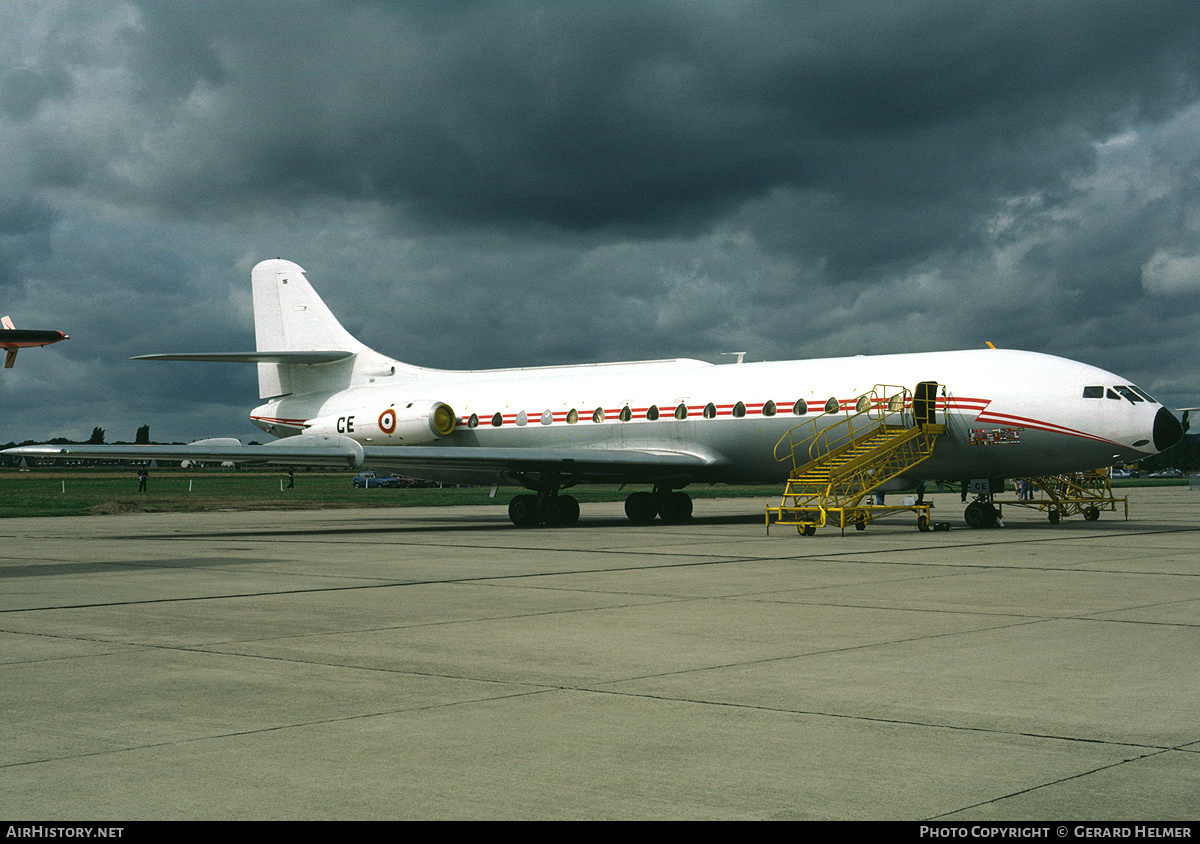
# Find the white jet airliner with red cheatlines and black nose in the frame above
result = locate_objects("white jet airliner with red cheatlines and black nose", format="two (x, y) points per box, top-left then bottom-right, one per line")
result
(8, 259), (1182, 526)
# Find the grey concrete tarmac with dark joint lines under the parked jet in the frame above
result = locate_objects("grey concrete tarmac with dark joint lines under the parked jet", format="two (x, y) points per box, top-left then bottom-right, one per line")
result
(0, 487), (1200, 821)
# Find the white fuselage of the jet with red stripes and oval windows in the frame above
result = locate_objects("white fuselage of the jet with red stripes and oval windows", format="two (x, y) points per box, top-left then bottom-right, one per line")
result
(251, 349), (1174, 483)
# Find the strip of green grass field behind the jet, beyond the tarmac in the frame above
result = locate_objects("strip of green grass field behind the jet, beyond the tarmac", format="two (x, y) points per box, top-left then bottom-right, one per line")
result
(0, 468), (1188, 517)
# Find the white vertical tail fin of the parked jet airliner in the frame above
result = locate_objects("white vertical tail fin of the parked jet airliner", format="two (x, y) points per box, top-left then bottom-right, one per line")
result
(251, 258), (412, 399)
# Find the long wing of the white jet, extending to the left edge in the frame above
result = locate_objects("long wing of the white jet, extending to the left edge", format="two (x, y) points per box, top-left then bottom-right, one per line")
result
(0, 435), (724, 483)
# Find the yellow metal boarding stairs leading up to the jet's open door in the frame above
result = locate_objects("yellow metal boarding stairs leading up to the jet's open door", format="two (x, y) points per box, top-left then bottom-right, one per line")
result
(766, 382), (946, 537)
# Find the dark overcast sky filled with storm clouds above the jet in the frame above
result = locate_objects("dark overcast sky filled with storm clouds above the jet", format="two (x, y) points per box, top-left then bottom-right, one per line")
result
(0, 0), (1200, 443)
